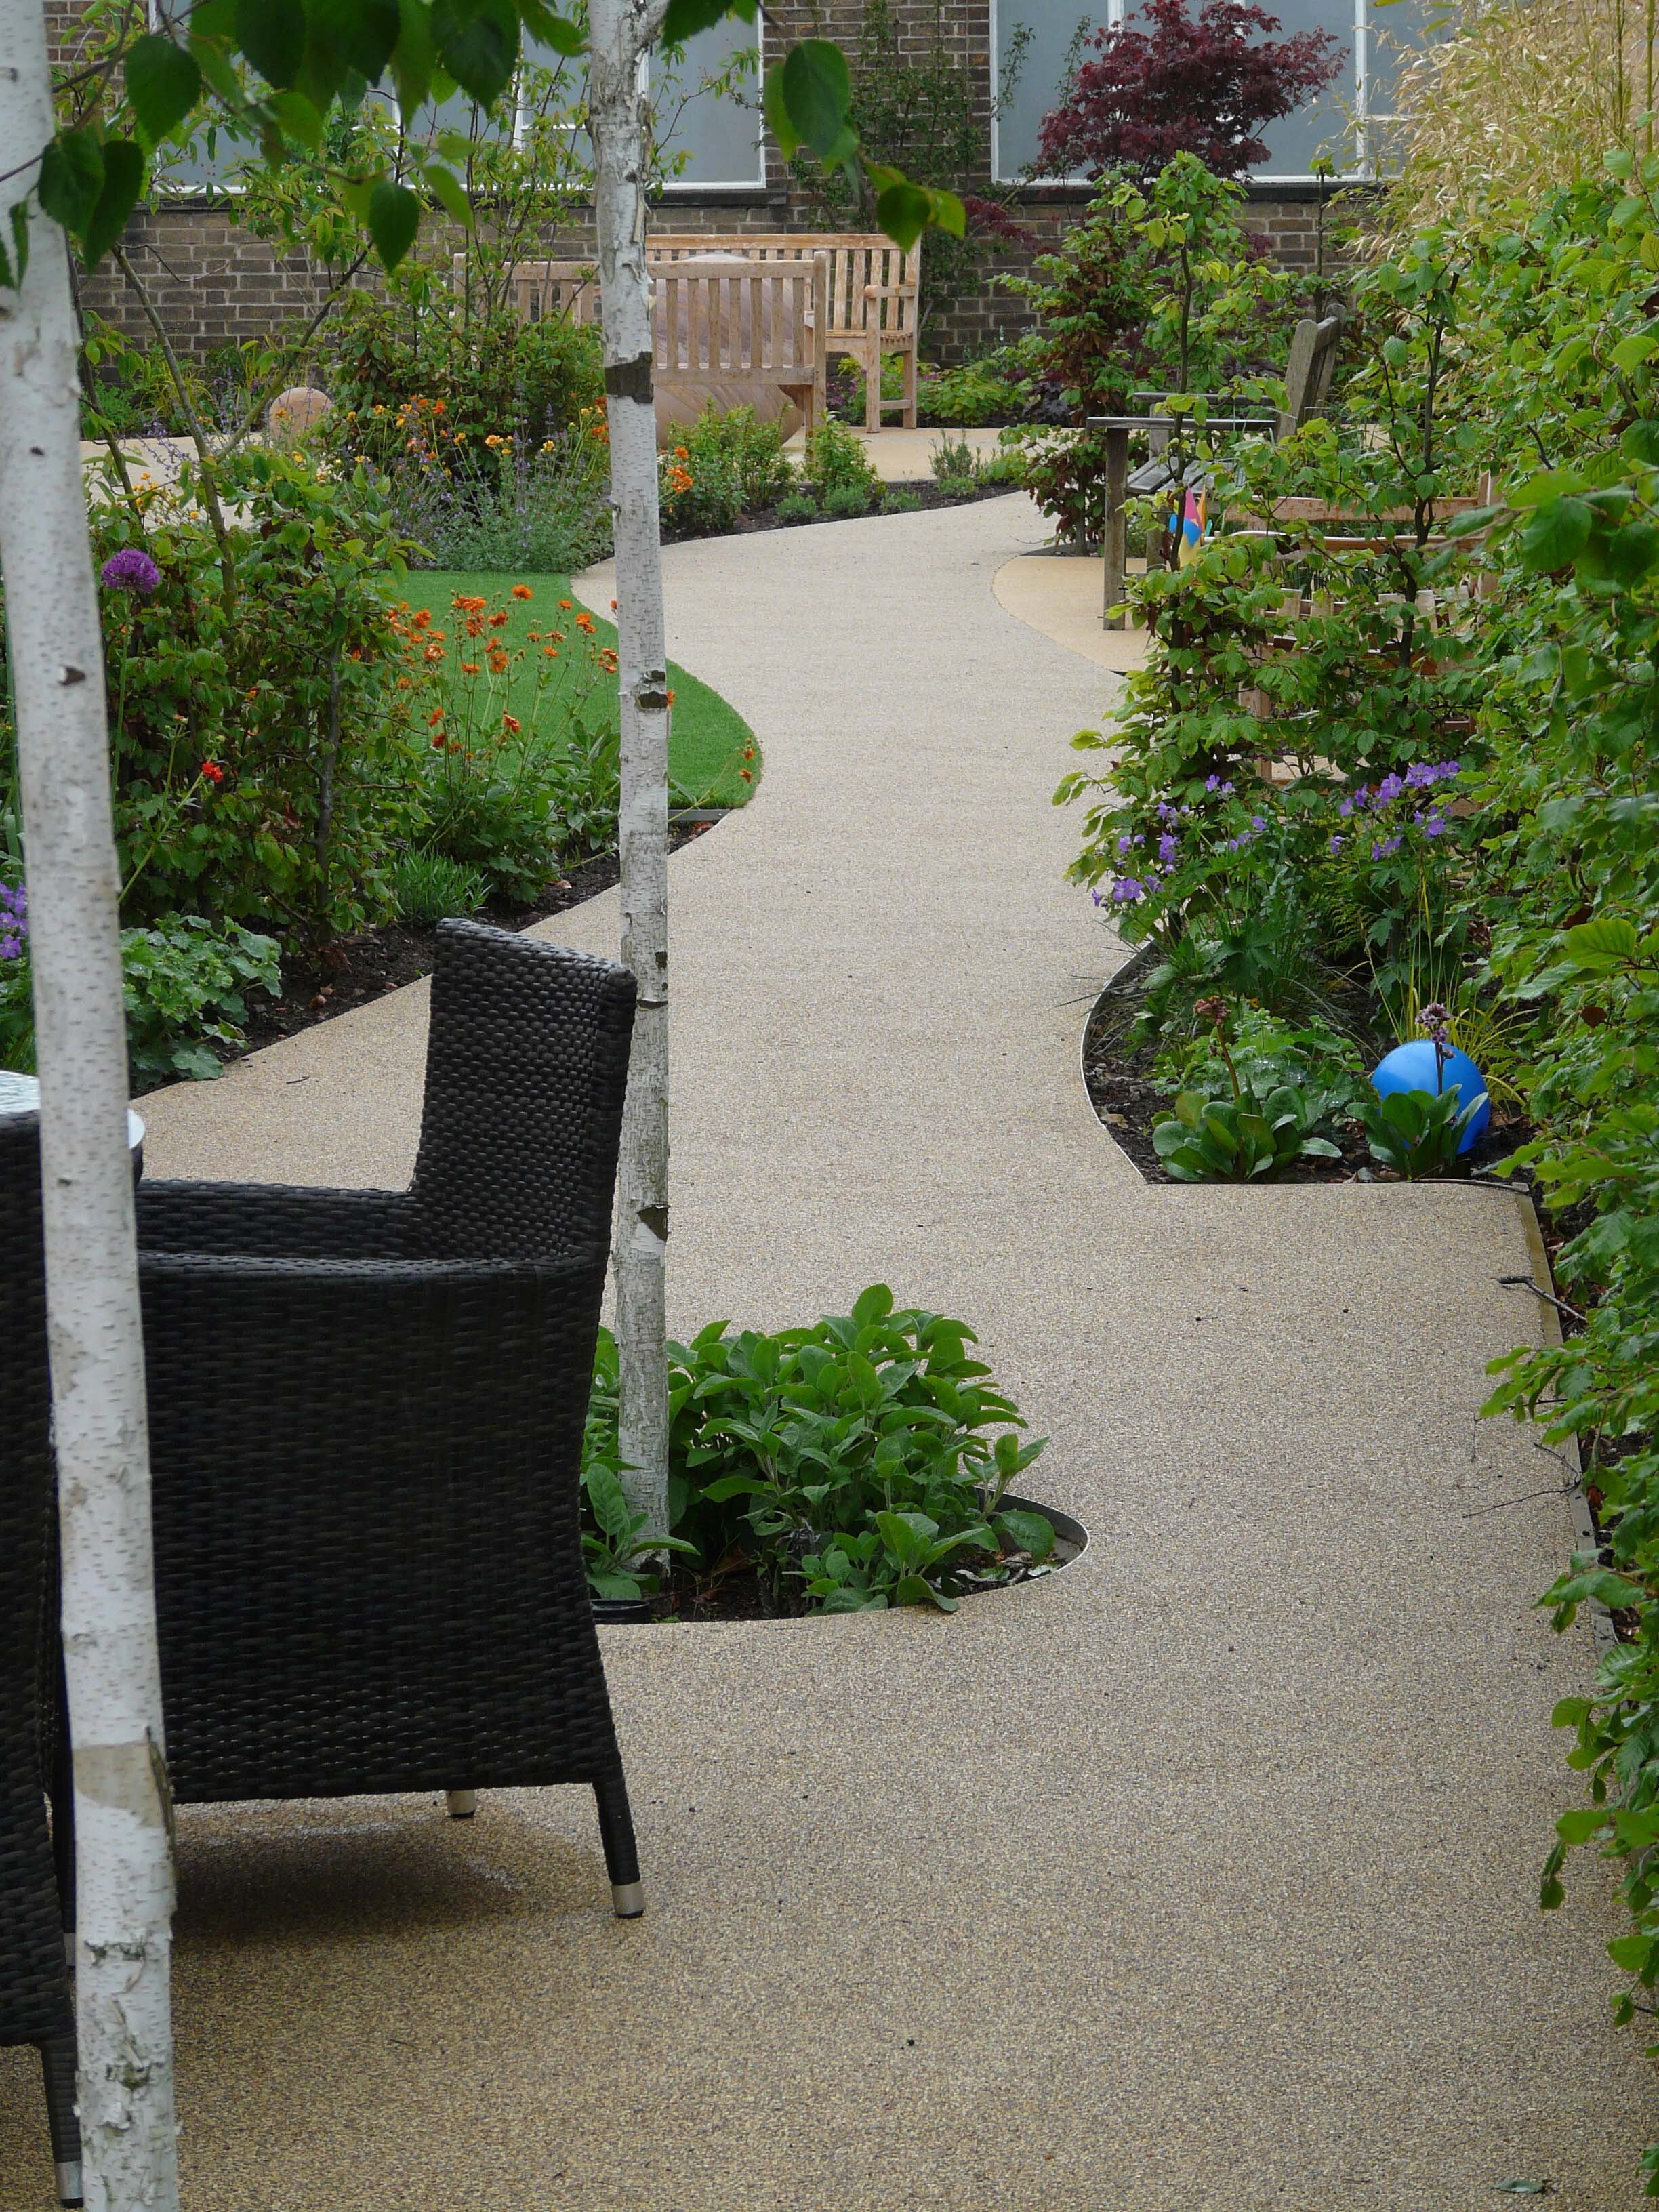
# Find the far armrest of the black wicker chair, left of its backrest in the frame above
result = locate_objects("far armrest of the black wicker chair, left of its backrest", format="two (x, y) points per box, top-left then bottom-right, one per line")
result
(137, 1181), (409, 1261)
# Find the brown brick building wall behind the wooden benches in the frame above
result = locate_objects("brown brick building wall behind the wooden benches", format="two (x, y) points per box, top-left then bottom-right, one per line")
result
(49, 0), (1371, 361)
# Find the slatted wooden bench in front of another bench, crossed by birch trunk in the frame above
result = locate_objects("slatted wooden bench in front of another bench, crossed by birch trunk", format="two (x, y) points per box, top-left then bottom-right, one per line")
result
(499, 252), (830, 443)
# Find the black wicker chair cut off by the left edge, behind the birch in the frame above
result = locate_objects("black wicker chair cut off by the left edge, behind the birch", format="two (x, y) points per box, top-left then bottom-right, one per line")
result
(0, 1115), (82, 2205)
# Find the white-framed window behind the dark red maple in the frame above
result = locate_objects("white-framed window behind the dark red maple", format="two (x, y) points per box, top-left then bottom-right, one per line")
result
(991, 0), (1431, 184)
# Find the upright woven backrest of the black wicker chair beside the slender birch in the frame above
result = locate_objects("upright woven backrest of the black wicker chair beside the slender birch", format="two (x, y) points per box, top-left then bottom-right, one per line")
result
(409, 922), (635, 1263)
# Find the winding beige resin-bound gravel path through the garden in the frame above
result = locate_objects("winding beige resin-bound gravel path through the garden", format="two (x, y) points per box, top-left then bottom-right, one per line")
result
(0, 497), (1654, 2212)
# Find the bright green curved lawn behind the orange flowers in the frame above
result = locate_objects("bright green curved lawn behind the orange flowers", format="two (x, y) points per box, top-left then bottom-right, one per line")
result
(407, 569), (761, 807)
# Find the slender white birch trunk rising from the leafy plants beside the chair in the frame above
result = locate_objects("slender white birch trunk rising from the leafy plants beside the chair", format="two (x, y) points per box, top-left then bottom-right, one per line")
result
(588, 0), (668, 1535)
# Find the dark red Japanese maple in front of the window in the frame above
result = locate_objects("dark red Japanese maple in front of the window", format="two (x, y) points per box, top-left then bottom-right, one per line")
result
(1040, 0), (1343, 182)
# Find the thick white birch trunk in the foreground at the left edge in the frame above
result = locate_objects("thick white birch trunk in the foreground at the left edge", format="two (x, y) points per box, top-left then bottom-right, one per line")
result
(0, 0), (179, 2212)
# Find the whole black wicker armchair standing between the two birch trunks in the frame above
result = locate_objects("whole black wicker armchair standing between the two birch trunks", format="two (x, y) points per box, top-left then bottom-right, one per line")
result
(140, 922), (644, 1916)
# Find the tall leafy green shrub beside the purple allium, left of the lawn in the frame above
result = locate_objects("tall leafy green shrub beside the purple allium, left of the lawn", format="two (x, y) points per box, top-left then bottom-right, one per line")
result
(0, 447), (429, 945)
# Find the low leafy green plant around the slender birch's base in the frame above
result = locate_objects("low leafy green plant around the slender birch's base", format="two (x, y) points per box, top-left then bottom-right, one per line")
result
(581, 1283), (1053, 1612)
